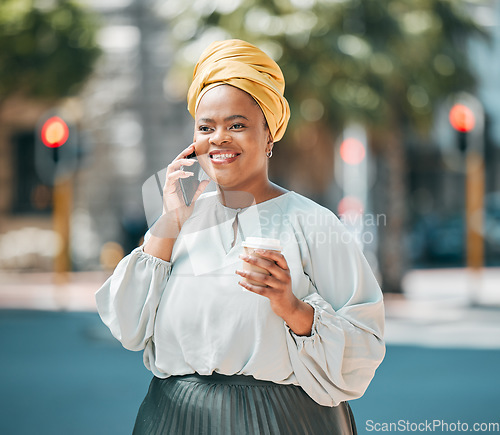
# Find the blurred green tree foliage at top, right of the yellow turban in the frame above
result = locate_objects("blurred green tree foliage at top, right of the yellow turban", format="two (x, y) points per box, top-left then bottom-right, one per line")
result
(170, 0), (481, 133)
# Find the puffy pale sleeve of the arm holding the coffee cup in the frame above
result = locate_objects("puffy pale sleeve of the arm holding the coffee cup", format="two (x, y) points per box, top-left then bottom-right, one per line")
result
(285, 209), (385, 406)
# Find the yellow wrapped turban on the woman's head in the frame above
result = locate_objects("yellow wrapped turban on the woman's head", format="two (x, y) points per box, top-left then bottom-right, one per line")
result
(187, 39), (290, 142)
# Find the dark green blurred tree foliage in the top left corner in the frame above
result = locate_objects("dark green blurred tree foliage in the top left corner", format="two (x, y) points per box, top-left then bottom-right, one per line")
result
(0, 0), (99, 102)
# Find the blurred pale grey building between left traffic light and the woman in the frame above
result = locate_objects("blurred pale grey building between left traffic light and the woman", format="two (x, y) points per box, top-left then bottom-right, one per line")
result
(73, 0), (190, 268)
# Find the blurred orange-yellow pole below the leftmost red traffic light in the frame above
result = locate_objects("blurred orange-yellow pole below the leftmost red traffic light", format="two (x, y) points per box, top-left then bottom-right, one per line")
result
(53, 177), (73, 284)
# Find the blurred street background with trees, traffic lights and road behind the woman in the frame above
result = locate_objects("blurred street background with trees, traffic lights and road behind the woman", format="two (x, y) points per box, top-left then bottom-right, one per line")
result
(0, 0), (500, 435)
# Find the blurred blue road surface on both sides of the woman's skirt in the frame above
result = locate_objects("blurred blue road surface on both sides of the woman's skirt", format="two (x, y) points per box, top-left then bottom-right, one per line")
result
(0, 310), (500, 435)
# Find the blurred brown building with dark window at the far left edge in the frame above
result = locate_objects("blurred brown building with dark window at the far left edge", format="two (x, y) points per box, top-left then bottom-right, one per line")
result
(0, 98), (57, 269)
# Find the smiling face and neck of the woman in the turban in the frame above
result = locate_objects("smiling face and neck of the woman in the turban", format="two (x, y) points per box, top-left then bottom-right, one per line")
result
(194, 85), (273, 197)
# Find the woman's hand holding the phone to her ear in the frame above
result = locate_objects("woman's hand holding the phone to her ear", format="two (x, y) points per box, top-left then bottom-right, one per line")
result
(163, 143), (209, 235)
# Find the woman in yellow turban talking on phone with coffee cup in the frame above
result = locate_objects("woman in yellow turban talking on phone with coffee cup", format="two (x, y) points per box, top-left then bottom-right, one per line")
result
(96, 40), (385, 435)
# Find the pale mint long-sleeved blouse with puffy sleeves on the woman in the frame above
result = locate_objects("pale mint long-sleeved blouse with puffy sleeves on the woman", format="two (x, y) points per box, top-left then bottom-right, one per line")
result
(96, 192), (385, 406)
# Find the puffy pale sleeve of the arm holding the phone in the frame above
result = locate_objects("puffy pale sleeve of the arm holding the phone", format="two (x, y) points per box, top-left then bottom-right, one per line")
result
(96, 246), (171, 351)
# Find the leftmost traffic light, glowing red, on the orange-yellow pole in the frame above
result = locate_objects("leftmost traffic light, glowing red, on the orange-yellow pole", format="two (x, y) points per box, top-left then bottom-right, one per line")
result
(35, 112), (78, 185)
